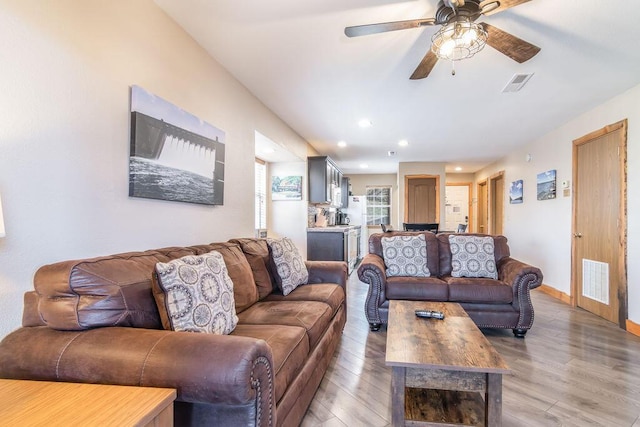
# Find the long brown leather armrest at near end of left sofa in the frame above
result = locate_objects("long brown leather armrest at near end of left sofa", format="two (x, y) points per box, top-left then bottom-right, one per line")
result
(0, 326), (275, 425)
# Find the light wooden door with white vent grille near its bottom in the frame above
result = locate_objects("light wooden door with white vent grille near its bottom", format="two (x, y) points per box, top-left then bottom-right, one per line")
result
(571, 120), (627, 328)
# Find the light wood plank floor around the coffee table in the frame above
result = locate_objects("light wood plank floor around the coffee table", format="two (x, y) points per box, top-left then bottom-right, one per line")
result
(302, 273), (640, 427)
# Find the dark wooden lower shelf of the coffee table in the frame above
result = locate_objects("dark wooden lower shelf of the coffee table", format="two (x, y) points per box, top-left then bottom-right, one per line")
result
(404, 388), (485, 426)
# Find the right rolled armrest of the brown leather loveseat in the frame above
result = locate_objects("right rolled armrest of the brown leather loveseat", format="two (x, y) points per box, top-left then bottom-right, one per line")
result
(498, 257), (542, 329)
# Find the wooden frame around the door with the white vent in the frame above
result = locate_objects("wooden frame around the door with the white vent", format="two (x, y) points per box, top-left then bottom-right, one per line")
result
(571, 119), (629, 330)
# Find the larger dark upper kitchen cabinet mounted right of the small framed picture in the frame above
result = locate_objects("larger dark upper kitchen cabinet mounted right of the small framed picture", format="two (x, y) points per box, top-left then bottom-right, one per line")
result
(307, 156), (342, 207)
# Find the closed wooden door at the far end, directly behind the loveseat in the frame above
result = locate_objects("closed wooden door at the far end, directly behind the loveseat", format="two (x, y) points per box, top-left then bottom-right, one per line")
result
(404, 175), (440, 223)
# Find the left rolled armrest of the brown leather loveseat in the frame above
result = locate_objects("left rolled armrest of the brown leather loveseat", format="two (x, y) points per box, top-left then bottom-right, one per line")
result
(358, 253), (387, 325)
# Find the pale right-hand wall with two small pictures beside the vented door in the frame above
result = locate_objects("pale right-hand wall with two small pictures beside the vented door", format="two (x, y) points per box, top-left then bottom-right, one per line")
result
(476, 86), (640, 324)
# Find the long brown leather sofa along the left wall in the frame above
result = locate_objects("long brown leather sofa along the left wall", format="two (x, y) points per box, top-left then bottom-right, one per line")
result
(0, 239), (347, 426)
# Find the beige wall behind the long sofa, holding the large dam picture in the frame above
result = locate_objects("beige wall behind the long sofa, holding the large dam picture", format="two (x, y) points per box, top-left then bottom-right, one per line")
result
(0, 0), (308, 338)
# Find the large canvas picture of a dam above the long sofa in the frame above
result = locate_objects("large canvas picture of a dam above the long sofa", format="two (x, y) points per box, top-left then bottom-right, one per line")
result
(129, 86), (225, 205)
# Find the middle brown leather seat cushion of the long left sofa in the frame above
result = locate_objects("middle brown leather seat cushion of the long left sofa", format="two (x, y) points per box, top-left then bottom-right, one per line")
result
(238, 300), (333, 349)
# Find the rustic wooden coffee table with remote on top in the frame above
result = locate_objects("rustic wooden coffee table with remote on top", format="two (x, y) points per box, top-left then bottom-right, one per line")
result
(386, 300), (510, 427)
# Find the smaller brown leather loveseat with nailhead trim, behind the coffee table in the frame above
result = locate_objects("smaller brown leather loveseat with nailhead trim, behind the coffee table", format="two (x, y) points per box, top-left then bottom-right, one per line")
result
(358, 232), (542, 338)
